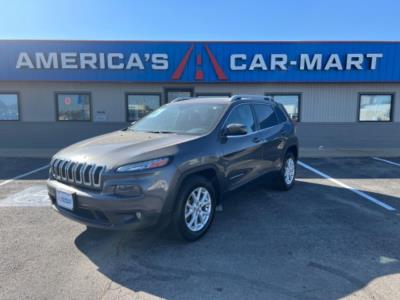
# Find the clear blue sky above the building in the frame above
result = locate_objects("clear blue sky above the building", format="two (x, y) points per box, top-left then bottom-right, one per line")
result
(0, 0), (400, 40)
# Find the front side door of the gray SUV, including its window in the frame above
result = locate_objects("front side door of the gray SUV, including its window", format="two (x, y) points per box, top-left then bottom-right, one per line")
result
(220, 104), (262, 190)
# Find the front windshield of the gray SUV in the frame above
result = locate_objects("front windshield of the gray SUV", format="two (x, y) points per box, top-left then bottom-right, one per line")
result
(128, 103), (226, 134)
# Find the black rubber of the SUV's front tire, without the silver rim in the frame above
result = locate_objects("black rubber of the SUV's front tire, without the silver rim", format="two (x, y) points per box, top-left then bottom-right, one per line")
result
(172, 176), (216, 241)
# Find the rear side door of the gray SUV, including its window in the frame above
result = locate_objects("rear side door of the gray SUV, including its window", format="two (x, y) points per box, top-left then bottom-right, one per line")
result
(253, 103), (285, 173)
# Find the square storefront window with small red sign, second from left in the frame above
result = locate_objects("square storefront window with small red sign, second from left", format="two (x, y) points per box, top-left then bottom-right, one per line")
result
(57, 94), (91, 121)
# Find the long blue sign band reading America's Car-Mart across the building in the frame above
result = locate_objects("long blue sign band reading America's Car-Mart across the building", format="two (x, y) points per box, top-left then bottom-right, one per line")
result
(0, 41), (400, 83)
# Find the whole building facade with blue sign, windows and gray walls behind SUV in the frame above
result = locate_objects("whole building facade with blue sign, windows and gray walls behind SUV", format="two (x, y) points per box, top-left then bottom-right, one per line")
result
(0, 41), (400, 151)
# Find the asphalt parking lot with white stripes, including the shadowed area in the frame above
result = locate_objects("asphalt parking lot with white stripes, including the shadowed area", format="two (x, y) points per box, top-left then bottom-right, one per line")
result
(0, 157), (400, 299)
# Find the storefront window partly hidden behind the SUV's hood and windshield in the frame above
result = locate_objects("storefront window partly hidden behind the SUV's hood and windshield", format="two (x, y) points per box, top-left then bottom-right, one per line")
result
(128, 95), (161, 122)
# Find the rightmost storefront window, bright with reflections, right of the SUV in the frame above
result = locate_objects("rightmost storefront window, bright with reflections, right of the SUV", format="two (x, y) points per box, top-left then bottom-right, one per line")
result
(359, 95), (393, 122)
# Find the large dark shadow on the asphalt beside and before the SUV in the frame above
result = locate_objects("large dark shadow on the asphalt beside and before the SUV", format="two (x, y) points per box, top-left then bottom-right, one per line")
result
(75, 181), (400, 299)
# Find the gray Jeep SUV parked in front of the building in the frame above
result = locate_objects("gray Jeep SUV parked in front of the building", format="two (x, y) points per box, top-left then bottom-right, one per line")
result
(47, 95), (298, 241)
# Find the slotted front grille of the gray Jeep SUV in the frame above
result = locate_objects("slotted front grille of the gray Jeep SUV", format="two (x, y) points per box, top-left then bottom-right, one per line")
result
(50, 159), (105, 189)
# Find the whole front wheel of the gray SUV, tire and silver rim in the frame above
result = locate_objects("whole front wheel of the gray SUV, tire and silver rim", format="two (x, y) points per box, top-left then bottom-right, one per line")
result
(173, 176), (216, 241)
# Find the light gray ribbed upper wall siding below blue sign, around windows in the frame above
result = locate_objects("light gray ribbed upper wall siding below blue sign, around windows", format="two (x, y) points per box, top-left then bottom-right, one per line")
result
(0, 82), (400, 123)
